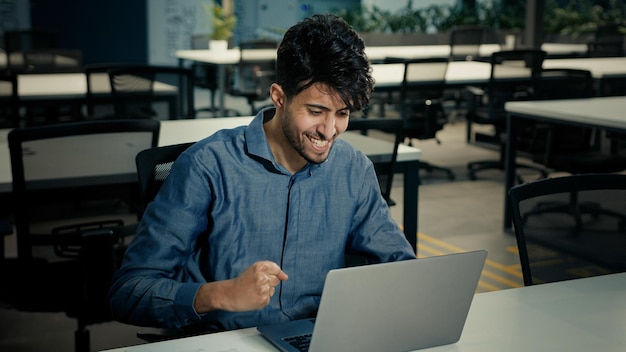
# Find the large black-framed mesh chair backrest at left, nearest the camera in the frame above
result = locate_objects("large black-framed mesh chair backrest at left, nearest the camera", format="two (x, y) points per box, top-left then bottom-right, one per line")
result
(8, 120), (160, 259)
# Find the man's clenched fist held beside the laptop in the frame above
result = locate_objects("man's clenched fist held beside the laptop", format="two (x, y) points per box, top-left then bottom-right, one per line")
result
(194, 261), (288, 313)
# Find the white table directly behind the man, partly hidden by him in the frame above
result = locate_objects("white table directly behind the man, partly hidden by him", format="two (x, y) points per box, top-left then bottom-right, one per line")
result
(0, 116), (421, 249)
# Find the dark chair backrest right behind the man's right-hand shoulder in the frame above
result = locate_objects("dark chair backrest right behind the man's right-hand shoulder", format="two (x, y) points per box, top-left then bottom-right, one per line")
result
(347, 118), (404, 204)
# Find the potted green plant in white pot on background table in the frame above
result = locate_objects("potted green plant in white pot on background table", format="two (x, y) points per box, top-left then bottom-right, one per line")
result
(202, 0), (237, 50)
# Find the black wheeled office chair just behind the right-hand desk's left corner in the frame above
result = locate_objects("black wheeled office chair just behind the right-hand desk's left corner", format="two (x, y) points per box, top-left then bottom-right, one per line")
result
(466, 49), (547, 183)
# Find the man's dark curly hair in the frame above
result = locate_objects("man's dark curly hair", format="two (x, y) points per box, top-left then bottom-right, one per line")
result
(276, 14), (374, 111)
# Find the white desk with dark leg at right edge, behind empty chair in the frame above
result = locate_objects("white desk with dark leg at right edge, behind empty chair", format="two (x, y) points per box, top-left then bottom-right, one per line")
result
(503, 96), (626, 230)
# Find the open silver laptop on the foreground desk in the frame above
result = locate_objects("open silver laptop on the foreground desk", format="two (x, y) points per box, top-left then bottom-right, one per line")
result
(257, 250), (487, 352)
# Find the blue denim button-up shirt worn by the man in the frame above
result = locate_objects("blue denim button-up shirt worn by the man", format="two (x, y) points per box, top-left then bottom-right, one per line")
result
(110, 109), (415, 330)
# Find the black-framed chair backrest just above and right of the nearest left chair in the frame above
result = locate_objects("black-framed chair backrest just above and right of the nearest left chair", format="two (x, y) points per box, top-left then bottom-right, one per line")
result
(108, 65), (195, 120)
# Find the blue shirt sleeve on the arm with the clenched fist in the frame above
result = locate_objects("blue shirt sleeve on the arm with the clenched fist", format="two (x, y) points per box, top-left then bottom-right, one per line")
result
(109, 153), (211, 328)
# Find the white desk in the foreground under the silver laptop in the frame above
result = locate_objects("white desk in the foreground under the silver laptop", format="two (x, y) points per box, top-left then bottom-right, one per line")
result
(100, 273), (626, 352)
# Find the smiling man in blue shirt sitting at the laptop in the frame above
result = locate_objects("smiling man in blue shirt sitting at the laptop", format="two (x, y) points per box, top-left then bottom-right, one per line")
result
(110, 15), (415, 331)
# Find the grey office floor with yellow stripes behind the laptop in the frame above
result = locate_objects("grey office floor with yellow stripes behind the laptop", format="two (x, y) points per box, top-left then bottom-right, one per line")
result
(0, 92), (532, 352)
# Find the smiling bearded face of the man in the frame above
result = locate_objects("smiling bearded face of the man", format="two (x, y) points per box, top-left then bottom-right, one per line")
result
(282, 83), (350, 164)
